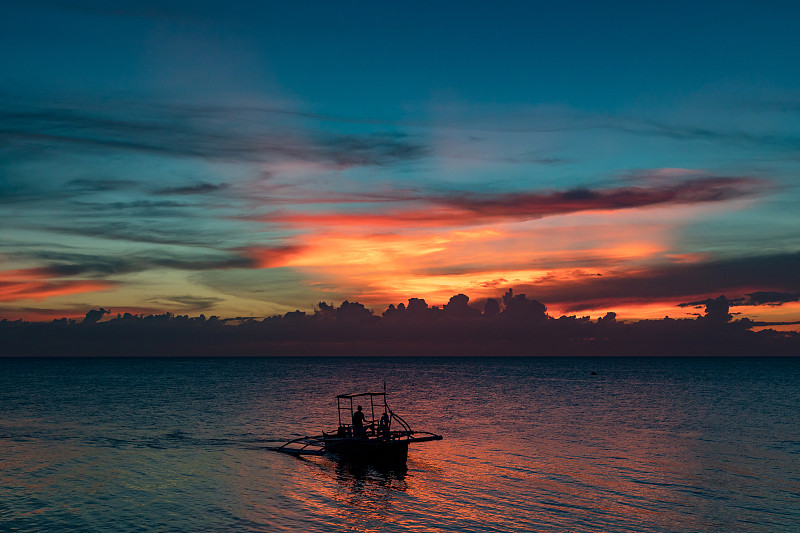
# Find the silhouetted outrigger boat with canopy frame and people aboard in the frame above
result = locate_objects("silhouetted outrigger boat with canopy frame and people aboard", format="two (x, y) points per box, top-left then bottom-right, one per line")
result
(270, 385), (442, 463)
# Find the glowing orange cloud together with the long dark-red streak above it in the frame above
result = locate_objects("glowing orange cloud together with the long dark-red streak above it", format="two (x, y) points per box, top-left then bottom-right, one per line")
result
(239, 177), (780, 318)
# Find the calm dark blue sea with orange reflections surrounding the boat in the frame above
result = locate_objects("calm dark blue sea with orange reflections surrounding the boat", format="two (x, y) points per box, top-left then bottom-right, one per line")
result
(0, 357), (800, 532)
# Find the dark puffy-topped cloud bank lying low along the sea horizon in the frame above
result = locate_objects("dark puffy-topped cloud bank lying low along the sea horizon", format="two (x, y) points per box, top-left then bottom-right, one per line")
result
(0, 290), (800, 356)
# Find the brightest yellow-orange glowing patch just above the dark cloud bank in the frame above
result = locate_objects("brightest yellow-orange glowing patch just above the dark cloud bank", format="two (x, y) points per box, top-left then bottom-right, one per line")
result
(246, 210), (669, 305)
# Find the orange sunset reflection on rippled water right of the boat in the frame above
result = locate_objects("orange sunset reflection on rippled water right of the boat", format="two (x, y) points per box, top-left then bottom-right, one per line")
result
(382, 396), (702, 531)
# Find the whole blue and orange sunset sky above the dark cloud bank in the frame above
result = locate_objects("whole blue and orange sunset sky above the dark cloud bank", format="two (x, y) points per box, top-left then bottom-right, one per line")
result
(0, 0), (800, 322)
